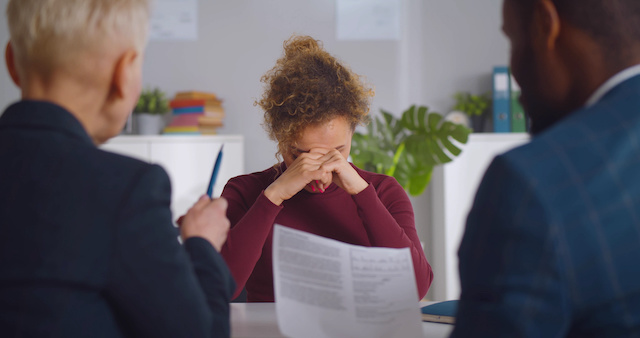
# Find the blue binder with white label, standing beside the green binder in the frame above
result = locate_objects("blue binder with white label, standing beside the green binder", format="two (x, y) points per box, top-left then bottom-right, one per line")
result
(493, 66), (511, 133)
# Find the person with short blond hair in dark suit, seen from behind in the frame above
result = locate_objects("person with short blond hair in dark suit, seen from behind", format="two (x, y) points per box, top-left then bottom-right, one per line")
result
(0, 0), (234, 337)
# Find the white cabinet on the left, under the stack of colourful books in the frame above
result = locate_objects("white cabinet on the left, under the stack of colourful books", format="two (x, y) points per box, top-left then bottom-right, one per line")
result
(101, 135), (244, 220)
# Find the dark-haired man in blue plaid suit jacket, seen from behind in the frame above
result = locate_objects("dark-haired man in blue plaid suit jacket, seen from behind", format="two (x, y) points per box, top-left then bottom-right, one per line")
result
(453, 0), (640, 338)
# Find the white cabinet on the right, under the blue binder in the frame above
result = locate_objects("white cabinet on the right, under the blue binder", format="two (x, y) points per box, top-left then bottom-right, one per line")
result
(430, 133), (529, 300)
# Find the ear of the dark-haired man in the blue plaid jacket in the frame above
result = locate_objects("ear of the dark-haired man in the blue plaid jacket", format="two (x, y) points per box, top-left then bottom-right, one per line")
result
(533, 0), (561, 50)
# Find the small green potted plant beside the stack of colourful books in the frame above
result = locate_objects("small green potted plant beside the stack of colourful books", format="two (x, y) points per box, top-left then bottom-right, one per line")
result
(133, 88), (169, 135)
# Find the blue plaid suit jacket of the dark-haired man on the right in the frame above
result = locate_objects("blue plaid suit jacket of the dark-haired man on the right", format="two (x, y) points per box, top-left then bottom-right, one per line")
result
(453, 76), (640, 338)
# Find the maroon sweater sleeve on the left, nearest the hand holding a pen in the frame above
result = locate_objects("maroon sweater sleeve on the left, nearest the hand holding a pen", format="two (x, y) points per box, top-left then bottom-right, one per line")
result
(221, 179), (283, 298)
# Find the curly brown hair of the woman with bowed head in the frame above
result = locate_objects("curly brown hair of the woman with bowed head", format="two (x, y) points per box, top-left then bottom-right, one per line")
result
(256, 35), (374, 157)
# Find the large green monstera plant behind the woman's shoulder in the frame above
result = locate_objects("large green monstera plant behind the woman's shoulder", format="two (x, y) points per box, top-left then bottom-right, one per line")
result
(351, 105), (471, 196)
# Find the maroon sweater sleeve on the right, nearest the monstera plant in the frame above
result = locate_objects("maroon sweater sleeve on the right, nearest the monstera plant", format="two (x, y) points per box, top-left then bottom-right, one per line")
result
(353, 177), (433, 299)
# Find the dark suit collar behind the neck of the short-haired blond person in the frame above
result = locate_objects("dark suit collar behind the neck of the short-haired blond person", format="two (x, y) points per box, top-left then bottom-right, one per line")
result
(0, 100), (93, 144)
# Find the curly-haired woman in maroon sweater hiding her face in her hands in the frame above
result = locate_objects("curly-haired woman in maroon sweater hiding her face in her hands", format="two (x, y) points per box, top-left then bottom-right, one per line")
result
(222, 36), (433, 302)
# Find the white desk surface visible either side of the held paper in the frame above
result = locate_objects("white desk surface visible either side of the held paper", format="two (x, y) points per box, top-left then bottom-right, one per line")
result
(231, 302), (453, 338)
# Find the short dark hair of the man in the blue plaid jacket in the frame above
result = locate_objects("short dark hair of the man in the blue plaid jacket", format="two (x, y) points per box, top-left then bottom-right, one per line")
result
(506, 0), (640, 52)
